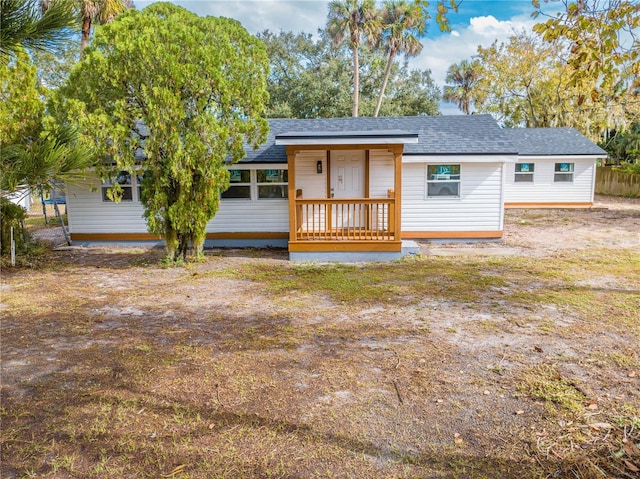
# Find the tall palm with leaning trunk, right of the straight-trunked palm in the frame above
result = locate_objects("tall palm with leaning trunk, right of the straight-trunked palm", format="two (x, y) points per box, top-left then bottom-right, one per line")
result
(373, 0), (429, 117)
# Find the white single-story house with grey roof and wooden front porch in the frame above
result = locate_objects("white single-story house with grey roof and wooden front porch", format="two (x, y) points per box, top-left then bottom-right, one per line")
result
(67, 115), (606, 260)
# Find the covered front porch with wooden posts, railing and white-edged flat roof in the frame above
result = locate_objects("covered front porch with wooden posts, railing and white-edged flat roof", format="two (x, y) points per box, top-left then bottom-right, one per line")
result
(276, 131), (417, 259)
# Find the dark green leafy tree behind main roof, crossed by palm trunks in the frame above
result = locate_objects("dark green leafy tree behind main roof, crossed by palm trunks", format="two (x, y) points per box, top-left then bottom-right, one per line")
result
(259, 31), (440, 118)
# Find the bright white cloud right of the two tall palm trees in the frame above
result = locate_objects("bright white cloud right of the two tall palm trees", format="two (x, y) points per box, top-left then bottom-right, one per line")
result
(411, 15), (535, 86)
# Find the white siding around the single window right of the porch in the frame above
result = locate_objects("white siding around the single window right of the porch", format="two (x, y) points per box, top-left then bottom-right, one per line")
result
(402, 163), (503, 236)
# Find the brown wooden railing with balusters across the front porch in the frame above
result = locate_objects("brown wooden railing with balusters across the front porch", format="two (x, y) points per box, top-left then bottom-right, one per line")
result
(295, 197), (397, 241)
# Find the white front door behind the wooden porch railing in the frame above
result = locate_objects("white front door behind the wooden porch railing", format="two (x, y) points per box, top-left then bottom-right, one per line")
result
(330, 150), (366, 228)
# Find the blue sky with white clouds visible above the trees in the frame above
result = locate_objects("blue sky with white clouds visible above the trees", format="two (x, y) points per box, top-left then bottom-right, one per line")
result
(135, 0), (559, 114)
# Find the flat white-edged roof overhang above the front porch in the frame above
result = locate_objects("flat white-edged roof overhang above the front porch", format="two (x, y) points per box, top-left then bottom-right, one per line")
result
(276, 130), (418, 146)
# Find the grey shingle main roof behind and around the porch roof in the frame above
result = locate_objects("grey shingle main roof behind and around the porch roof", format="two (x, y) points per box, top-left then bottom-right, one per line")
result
(242, 115), (517, 163)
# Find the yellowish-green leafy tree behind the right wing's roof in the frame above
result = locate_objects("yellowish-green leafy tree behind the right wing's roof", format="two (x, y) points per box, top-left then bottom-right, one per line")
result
(474, 32), (631, 141)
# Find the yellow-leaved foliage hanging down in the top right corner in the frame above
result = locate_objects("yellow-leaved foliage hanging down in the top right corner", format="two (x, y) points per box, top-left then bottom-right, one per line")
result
(533, 0), (640, 150)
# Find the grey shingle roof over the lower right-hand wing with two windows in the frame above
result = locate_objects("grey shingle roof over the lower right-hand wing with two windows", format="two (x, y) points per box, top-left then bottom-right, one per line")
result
(504, 128), (607, 157)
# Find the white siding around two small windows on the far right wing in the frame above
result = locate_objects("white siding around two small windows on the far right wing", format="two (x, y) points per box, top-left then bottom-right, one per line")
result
(504, 156), (596, 206)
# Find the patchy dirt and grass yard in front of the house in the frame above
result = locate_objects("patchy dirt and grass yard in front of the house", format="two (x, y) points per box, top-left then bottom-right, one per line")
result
(0, 197), (640, 479)
